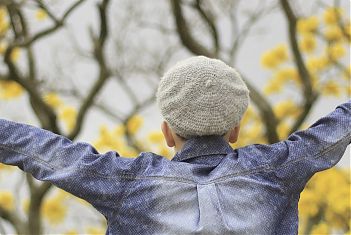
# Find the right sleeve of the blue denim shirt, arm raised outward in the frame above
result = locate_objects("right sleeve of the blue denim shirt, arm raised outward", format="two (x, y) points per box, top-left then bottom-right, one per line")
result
(242, 100), (351, 191)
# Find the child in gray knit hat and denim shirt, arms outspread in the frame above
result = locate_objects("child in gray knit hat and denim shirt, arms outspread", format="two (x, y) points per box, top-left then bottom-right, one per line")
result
(0, 56), (351, 234)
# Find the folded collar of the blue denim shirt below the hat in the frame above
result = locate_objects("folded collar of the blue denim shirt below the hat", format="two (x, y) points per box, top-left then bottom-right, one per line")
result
(172, 135), (233, 162)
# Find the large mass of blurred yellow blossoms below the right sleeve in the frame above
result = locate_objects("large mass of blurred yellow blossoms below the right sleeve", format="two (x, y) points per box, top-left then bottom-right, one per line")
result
(299, 168), (351, 234)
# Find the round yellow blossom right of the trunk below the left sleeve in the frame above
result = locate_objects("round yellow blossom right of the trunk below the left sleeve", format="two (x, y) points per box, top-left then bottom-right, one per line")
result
(41, 197), (67, 225)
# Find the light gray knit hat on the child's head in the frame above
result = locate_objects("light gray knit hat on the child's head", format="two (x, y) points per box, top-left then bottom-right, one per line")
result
(156, 56), (249, 139)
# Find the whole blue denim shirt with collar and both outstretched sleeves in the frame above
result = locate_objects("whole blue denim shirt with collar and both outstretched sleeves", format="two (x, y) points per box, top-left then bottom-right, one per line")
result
(0, 101), (351, 235)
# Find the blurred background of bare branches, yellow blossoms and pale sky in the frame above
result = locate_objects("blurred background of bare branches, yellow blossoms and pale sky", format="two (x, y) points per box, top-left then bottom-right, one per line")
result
(0, 0), (351, 234)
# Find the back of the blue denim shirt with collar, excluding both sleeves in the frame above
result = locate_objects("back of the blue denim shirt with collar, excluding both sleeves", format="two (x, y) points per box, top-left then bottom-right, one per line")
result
(111, 137), (299, 234)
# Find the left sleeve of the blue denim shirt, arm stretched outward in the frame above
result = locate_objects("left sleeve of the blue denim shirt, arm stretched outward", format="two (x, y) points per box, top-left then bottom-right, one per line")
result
(0, 119), (134, 213)
